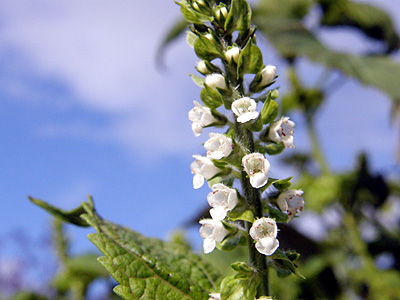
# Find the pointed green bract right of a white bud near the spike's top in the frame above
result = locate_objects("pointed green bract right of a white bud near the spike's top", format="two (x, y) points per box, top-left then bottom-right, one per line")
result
(237, 38), (264, 77)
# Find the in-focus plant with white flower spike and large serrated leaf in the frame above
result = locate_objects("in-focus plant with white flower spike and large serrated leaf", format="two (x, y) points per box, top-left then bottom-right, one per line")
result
(31, 0), (304, 300)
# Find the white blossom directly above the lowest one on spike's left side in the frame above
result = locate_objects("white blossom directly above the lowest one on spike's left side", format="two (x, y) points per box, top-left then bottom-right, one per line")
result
(207, 183), (239, 221)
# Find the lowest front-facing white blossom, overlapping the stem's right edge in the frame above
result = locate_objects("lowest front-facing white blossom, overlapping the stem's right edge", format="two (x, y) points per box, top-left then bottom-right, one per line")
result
(250, 218), (279, 255)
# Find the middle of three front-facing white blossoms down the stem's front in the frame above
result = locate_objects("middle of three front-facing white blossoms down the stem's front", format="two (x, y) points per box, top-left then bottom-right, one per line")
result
(242, 153), (270, 188)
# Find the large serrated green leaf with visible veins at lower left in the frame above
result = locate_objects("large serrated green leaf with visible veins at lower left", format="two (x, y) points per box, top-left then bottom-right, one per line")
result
(82, 201), (219, 300)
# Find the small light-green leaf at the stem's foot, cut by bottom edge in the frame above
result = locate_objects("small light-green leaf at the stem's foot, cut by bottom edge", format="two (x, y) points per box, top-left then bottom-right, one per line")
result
(221, 272), (260, 300)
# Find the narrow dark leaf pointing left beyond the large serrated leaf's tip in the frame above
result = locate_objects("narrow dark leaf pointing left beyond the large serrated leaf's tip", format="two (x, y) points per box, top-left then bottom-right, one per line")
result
(28, 196), (90, 227)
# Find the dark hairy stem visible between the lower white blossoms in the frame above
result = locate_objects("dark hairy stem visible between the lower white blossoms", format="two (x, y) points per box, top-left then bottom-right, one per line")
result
(236, 123), (270, 298)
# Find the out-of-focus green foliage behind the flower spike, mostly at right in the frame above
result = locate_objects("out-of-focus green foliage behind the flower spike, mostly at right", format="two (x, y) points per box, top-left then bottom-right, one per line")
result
(161, 0), (400, 300)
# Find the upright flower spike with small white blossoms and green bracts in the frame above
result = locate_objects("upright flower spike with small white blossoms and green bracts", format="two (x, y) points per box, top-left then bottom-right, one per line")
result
(179, 0), (304, 299)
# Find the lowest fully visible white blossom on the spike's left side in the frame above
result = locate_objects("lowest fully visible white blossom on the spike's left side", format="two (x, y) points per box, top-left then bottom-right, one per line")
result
(199, 219), (229, 254)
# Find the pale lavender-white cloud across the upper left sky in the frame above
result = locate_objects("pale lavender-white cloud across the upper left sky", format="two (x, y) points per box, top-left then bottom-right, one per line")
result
(0, 0), (205, 159)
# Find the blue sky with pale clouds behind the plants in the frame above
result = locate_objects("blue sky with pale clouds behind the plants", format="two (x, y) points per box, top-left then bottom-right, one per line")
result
(0, 0), (400, 292)
